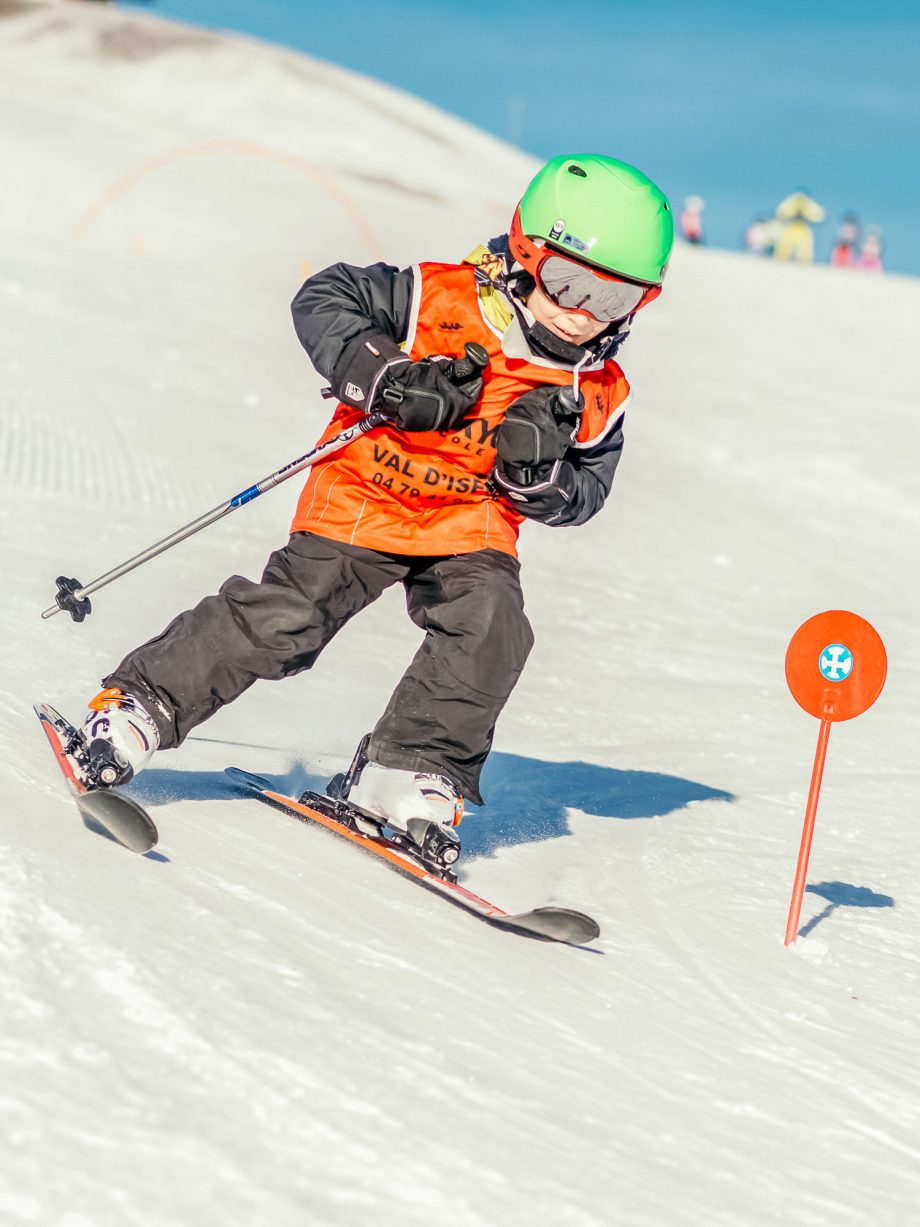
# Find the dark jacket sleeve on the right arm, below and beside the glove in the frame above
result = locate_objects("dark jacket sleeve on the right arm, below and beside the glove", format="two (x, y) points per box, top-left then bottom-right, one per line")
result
(492, 417), (623, 528)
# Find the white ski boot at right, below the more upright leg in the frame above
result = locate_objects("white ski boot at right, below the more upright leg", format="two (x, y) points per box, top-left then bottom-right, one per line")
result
(328, 736), (464, 876)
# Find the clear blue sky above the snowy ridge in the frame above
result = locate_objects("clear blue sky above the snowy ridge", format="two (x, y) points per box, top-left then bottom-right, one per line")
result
(123, 0), (920, 275)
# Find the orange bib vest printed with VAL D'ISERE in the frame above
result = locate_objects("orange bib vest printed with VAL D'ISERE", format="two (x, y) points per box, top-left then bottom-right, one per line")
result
(291, 264), (629, 556)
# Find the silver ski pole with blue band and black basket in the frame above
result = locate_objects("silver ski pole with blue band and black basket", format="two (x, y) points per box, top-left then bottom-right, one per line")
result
(42, 341), (488, 622)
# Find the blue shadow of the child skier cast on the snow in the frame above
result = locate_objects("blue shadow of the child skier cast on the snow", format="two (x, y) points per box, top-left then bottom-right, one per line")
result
(131, 751), (735, 859)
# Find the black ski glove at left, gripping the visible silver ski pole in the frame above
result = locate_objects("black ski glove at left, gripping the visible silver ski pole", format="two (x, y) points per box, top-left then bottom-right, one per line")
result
(331, 333), (482, 431)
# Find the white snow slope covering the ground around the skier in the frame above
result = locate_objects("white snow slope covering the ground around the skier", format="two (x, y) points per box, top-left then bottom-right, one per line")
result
(0, 2), (920, 1227)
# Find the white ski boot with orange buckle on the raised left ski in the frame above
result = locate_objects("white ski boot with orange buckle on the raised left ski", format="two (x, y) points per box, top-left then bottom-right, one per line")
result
(79, 687), (159, 788)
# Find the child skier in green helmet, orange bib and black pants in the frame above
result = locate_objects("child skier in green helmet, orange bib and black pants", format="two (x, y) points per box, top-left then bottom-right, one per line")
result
(75, 156), (673, 852)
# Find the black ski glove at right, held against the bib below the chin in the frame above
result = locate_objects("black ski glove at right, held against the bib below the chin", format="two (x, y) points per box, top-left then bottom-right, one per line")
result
(496, 387), (585, 486)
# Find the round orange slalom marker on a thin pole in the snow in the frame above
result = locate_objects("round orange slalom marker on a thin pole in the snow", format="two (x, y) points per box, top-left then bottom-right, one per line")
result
(785, 610), (888, 946)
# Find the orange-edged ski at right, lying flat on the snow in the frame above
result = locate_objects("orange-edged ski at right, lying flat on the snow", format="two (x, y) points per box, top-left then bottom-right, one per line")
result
(224, 767), (600, 946)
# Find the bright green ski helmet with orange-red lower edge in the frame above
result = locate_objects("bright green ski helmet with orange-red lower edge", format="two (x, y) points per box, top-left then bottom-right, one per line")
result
(508, 153), (673, 309)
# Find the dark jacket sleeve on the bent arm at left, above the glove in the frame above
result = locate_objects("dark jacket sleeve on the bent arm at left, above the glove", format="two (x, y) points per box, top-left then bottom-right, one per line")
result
(291, 264), (415, 380)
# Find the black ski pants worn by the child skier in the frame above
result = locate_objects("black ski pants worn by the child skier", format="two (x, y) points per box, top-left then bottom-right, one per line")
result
(103, 533), (534, 805)
